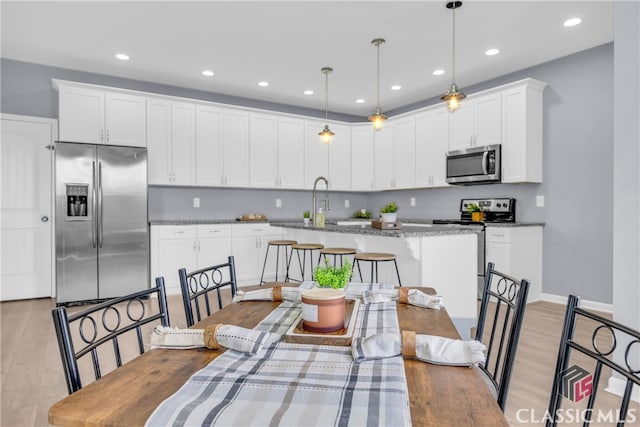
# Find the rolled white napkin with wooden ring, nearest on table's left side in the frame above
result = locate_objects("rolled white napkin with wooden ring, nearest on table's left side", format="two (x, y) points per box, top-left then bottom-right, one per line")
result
(151, 324), (282, 355)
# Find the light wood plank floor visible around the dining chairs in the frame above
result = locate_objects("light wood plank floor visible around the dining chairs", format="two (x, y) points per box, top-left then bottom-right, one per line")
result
(0, 296), (640, 427)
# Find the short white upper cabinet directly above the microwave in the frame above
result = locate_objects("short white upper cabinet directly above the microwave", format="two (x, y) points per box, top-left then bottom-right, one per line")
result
(449, 92), (502, 150)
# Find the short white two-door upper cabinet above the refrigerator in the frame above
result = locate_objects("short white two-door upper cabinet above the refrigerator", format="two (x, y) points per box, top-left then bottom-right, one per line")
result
(57, 82), (147, 147)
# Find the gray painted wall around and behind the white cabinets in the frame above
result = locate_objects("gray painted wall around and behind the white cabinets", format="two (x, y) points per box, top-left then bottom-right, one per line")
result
(1, 44), (613, 303)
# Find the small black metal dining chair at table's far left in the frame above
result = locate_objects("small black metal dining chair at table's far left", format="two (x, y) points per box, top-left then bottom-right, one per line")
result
(178, 255), (238, 326)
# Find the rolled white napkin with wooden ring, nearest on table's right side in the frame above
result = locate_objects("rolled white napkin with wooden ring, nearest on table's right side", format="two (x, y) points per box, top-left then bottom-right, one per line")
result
(351, 332), (486, 366)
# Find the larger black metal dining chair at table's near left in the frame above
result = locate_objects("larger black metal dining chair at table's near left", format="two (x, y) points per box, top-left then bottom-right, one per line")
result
(51, 280), (170, 394)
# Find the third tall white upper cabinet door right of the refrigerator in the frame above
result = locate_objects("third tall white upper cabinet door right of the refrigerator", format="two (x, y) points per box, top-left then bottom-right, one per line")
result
(195, 105), (223, 186)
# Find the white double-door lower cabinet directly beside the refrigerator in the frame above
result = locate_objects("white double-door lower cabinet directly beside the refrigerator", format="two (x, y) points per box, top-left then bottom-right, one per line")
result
(151, 224), (231, 294)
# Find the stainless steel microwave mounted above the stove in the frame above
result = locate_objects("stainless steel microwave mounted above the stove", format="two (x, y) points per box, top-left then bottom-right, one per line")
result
(447, 144), (502, 185)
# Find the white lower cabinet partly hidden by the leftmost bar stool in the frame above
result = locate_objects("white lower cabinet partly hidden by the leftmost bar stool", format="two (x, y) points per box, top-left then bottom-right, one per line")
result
(231, 223), (282, 286)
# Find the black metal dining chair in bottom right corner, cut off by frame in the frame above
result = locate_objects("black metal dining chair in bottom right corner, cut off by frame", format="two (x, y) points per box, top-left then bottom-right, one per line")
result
(545, 295), (640, 426)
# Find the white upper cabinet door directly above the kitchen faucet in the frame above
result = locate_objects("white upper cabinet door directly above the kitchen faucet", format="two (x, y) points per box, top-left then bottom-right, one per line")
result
(304, 121), (330, 189)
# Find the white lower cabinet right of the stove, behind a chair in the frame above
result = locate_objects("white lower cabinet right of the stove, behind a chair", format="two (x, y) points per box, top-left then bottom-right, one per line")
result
(485, 226), (542, 302)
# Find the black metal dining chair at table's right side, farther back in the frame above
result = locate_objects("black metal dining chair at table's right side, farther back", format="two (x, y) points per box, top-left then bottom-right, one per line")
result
(475, 262), (529, 412)
